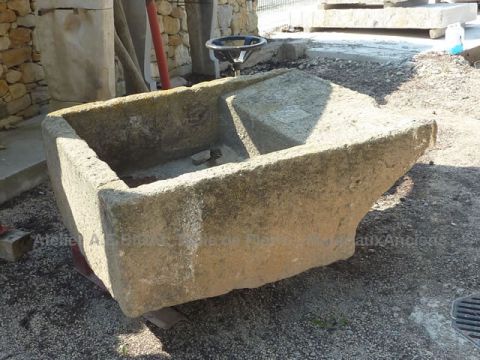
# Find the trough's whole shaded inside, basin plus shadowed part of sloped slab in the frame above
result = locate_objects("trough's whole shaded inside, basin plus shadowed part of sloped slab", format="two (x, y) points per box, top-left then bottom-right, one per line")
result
(60, 72), (329, 187)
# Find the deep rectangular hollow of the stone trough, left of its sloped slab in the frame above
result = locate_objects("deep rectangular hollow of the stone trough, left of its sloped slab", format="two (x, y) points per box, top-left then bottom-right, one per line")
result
(57, 81), (278, 187)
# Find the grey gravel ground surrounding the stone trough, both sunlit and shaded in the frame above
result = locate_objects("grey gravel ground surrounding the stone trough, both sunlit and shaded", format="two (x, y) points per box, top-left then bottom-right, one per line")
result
(0, 54), (480, 360)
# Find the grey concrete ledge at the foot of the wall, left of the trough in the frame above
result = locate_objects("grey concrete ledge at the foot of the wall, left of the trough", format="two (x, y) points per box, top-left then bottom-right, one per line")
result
(0, 116), (48, 204)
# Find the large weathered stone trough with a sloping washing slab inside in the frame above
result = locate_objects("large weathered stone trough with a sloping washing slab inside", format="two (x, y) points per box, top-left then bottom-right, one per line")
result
(43, 70), (436, 316)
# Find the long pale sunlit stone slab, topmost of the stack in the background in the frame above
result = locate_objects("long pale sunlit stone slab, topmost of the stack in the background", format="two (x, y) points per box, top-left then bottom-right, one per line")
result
(292, 3), (477, 30)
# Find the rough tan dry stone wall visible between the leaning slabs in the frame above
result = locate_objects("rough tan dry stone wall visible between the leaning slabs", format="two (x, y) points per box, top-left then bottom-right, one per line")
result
(0, 0), (258, 129)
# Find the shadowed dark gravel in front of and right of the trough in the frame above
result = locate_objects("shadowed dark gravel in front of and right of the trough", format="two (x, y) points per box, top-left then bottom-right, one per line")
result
(135, 164), (480, 359)
